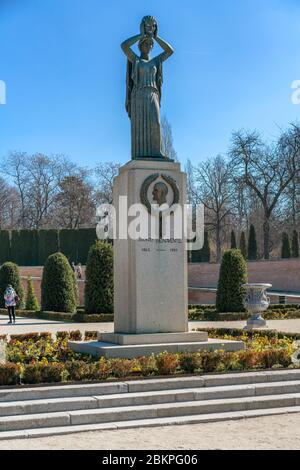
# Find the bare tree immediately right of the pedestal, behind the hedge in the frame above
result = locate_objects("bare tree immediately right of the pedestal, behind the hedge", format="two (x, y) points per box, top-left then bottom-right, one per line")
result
(192, 156), (233, 262)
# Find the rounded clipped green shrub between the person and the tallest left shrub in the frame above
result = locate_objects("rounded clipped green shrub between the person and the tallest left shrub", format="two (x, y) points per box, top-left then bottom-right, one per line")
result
(41, 253), (77, 313)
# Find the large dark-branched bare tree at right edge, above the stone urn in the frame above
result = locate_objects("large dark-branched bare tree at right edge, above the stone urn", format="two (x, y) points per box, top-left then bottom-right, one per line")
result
(230, 125), (300, 259)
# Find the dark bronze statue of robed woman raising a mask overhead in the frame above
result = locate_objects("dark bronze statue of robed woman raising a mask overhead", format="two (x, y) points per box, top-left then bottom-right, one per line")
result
(121, 16), (174, 159)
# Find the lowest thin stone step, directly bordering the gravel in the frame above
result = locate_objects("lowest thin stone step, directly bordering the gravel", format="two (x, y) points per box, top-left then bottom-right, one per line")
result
(0, 406), (300, 441)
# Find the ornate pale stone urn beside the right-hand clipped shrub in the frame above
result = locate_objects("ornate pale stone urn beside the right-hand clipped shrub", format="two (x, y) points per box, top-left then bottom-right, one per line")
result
(242, 284), (272, 329)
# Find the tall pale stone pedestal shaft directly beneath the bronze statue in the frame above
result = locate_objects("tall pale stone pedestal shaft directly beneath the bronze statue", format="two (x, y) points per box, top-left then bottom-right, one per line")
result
(114, 160), (188, 334)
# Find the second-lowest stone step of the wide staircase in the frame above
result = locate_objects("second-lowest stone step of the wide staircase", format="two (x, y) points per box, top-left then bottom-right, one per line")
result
(0, 393), (300, 431)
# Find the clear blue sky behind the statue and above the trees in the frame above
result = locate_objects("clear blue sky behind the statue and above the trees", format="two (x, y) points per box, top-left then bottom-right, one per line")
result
(0, 0), (300, 166)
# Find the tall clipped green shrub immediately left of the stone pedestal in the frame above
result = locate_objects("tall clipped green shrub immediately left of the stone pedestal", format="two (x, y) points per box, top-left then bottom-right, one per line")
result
(85, 241), (114, 313)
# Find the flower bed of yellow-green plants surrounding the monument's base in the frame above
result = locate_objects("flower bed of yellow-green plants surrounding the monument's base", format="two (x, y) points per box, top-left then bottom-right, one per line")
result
(0, 329), (300, 386)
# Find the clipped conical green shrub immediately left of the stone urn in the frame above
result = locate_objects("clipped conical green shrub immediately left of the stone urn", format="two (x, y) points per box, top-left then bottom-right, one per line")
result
(216, 250), (247, 312)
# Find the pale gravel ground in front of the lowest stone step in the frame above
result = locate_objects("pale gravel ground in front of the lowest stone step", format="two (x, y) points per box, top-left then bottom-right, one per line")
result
(0, 414), (300, 450)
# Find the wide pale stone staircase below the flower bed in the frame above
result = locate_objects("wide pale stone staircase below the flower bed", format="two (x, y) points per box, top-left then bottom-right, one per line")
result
(0, 369), (300, 440)
